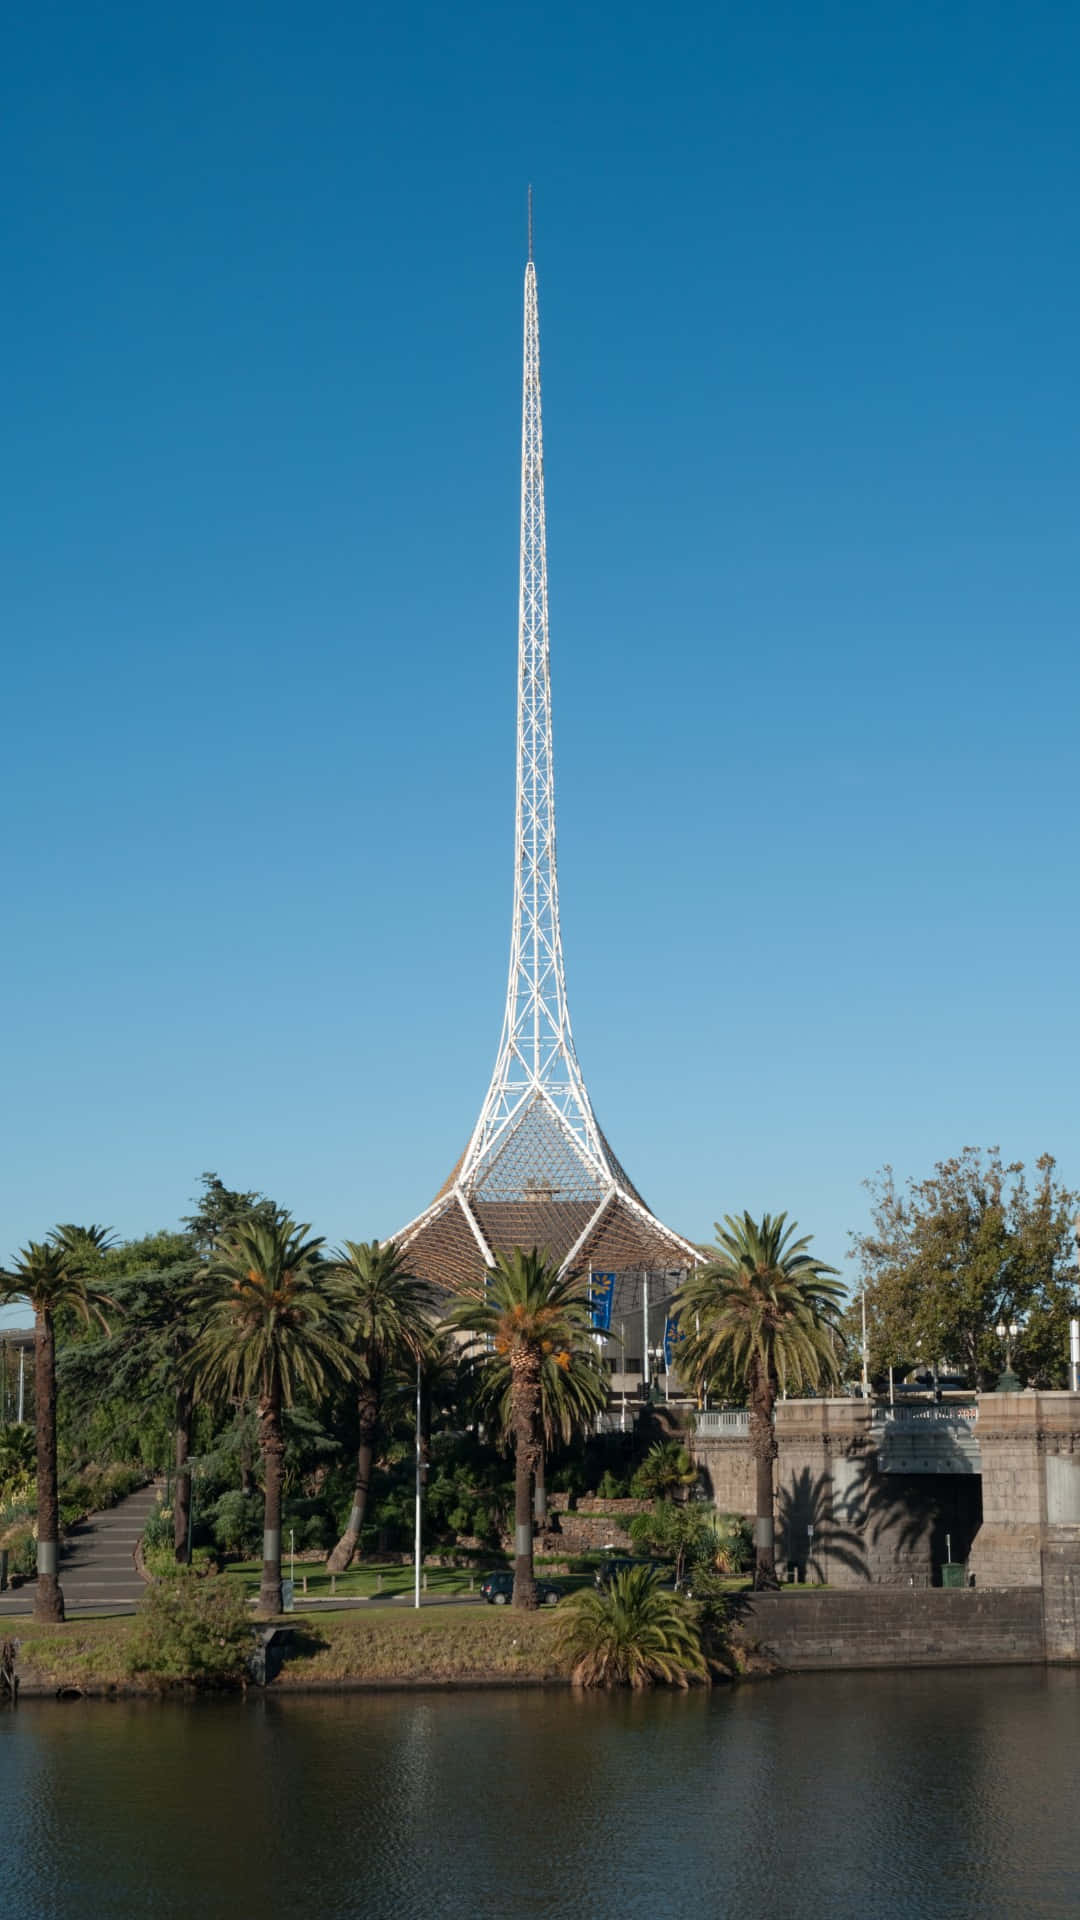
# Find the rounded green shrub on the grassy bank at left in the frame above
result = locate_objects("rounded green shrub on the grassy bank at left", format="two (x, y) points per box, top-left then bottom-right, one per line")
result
(129, 1572), (252, 1688)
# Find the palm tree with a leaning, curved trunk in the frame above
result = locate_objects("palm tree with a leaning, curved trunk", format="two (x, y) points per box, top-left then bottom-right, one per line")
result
(327, 1240), (434, 1572)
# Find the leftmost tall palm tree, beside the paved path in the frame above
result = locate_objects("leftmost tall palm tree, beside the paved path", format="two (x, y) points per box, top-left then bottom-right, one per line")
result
(0, 1229), (113, 1620)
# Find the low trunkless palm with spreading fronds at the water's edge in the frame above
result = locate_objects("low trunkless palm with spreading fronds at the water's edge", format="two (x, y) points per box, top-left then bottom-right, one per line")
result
(557, 1567), (709, 1688)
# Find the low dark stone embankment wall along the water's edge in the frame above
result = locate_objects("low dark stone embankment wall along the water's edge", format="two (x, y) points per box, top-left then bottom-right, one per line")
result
(740, 1586), (1045, 1670)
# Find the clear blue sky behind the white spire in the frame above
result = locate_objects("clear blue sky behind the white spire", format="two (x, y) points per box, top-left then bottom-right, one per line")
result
(0, 0), (1080, 1313)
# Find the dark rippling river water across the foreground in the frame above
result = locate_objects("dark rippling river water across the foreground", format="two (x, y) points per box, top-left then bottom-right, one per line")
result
(0, 1668), (1080, 1920)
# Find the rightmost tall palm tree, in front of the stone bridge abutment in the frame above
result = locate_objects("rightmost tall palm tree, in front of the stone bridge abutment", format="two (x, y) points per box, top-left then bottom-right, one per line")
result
(675, 1213), (844, 1586)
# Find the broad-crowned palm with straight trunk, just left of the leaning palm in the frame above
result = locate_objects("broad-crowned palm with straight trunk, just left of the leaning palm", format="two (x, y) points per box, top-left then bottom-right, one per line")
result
(186, 1213), (354, 1613)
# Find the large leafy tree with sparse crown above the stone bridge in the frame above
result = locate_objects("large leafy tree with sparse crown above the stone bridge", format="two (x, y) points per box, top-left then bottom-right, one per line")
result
(847, 1146), (1080, 1386)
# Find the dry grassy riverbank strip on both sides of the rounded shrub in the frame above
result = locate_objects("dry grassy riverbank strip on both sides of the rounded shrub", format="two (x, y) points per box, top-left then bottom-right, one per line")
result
(12, 1607), (565, 1693)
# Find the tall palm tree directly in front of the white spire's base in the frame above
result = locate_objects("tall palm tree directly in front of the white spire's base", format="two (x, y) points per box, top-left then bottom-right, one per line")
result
(448, 1246), (590, 1607)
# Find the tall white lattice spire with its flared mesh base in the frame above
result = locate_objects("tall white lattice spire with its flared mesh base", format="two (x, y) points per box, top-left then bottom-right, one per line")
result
(396, 236), (700, 1304)
